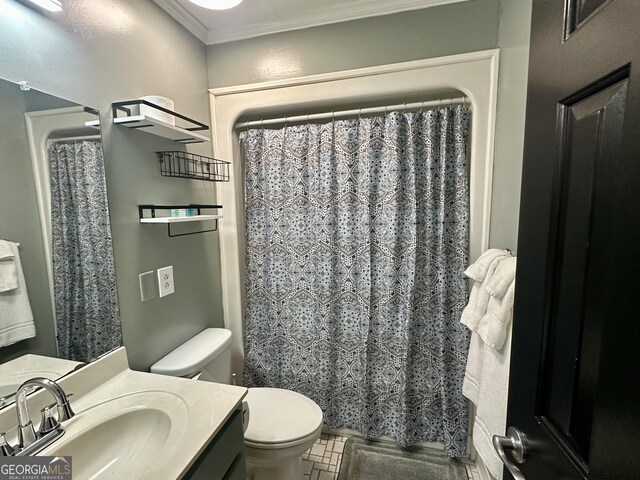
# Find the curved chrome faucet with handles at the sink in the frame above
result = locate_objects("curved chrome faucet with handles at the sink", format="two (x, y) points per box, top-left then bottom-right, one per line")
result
(14, 377), (75, 455)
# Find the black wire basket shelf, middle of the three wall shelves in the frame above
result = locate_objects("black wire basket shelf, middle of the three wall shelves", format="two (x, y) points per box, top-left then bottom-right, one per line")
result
(157, 151), (230, 182)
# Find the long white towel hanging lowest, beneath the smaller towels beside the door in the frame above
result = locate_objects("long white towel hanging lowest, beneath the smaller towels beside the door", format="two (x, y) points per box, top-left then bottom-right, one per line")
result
(462, 322), (511, 480)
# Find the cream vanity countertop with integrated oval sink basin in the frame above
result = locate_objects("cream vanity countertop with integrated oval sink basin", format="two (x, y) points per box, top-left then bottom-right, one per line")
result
(0, 347), (247, 480)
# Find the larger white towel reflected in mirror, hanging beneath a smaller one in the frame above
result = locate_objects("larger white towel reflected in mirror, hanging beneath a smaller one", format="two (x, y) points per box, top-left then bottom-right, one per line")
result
(0, 242), (36, 347)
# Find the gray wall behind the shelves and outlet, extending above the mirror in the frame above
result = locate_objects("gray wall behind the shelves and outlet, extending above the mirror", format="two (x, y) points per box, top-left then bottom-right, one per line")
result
(0, 0), (222, 370)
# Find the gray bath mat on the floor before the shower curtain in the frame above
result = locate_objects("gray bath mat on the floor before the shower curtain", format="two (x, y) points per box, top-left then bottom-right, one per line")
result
(338, 438), (468, 480)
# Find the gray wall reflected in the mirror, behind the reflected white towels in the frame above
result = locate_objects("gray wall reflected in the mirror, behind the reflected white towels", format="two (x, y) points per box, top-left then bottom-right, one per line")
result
(0, 80), (57, 362)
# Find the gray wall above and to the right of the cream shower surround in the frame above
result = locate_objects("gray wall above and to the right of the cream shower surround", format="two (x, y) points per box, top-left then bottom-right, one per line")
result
(207, 0), (531, 251)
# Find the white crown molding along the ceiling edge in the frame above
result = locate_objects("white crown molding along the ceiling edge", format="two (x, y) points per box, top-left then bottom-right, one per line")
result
(153, 0), (468, 45)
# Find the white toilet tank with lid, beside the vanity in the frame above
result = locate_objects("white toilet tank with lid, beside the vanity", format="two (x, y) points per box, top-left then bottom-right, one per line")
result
(151, 328), (231, 384)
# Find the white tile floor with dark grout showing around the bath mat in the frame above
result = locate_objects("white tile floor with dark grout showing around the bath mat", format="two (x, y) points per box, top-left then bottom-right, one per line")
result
(302, 433), (480, 480)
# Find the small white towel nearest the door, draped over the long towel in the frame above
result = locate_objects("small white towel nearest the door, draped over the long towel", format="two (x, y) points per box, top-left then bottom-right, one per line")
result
(476, 257), (516, 350)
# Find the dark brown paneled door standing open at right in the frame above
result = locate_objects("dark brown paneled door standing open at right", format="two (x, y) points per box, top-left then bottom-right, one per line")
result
(505, 0), (640, 480)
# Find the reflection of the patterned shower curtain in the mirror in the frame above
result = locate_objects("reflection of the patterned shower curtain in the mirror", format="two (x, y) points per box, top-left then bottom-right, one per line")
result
(49, 140), (122, 362)
